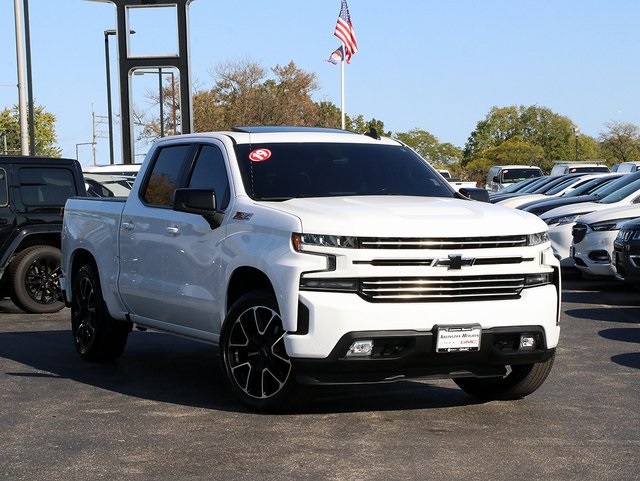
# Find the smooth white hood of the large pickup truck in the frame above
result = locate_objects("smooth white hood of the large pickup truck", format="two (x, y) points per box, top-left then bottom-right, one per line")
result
(265, 196), (547, 237)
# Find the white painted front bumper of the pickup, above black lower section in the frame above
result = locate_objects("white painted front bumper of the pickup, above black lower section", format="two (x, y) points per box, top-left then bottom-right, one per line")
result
(284, 280), (560, 361)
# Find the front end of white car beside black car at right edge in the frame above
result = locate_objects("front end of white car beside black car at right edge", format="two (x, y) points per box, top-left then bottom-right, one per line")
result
(570, 204), (640, 277)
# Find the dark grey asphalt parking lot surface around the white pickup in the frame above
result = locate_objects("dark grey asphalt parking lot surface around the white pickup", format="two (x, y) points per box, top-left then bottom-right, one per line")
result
(0, 268), (640, 481)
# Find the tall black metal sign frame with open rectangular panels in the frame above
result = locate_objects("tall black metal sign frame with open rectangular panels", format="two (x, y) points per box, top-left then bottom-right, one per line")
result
(94, 0), (193, 164)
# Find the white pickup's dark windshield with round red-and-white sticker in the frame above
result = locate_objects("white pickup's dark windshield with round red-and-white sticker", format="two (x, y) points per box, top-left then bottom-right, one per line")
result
(235, 142), (454, 200)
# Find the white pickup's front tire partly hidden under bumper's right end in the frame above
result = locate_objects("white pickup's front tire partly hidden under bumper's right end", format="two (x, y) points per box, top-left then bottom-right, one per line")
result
(453, 353), (555, 401)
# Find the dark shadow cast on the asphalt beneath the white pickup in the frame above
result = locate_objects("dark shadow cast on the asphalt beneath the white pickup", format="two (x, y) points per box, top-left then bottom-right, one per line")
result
(0, 330), (475, 414)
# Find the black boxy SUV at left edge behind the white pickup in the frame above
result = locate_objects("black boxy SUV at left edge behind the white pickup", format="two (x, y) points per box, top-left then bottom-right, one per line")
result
(0, 156), (86, 313)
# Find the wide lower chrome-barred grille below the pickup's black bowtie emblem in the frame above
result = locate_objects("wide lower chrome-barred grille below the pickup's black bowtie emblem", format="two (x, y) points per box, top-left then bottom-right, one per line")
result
(359, 274), (525, 302)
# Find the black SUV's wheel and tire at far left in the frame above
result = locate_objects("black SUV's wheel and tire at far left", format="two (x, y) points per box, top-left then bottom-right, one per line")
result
(9, 245), (64, 314)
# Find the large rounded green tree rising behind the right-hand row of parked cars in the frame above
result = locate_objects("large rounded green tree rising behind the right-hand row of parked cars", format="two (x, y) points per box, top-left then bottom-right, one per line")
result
(463, 105), (594, 170)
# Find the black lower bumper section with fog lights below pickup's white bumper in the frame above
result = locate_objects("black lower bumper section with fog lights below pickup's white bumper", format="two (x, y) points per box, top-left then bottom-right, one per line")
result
(292, 326), (555, 384)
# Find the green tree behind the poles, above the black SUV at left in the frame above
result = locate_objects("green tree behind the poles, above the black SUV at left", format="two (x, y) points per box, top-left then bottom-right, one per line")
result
(0, 105), (62, 157)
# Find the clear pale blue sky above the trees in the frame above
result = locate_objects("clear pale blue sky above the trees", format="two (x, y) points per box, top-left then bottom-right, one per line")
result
(0, 0), (640, 165)
